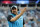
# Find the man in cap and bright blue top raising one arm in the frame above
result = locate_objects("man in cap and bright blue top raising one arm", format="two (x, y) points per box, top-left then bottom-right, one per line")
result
(7, 6), (26, 27)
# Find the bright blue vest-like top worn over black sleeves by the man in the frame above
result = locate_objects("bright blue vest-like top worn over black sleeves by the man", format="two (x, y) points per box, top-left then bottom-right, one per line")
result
(8, 14), (23, 27)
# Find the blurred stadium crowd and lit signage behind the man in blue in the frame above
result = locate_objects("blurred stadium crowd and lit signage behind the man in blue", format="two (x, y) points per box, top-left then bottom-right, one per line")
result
(0, 0), (40, 27)
